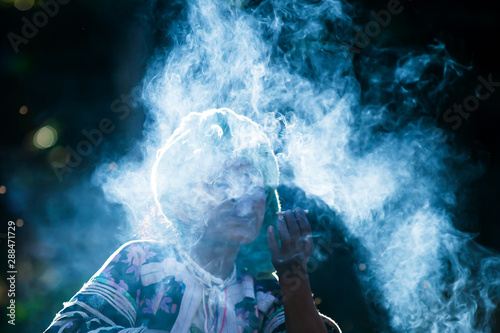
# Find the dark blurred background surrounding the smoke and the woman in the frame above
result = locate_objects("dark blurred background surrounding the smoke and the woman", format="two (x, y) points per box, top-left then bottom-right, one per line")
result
(0, 0), (500, 332)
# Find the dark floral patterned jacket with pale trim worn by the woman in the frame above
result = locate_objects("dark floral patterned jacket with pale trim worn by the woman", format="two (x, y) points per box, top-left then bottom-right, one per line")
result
(45, 241), (340, 333)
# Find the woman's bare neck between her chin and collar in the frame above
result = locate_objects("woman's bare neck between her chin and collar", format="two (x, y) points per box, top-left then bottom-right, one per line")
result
(186, 238), (240, 280)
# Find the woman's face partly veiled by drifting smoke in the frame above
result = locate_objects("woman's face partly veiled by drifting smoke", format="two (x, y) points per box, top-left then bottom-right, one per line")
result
(200, 162), (267, 245)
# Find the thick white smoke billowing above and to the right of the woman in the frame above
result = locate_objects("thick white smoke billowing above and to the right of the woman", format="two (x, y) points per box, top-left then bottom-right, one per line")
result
(95, 0), (500, 332)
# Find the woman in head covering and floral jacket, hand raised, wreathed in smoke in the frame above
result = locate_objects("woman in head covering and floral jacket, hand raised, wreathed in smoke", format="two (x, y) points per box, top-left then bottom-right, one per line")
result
(46, 109), (340, 333)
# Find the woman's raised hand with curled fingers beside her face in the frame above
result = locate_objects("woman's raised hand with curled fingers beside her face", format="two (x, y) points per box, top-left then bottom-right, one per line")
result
(267, 207), (314, 276)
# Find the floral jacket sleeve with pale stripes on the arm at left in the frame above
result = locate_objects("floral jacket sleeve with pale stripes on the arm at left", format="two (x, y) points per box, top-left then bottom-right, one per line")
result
(45, 242), (148, 333)
